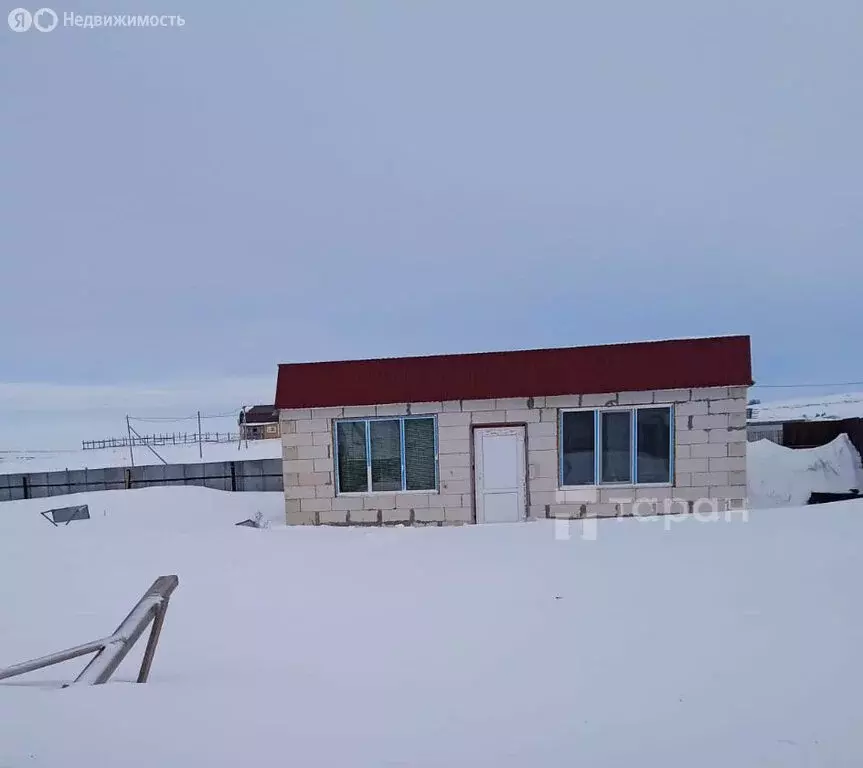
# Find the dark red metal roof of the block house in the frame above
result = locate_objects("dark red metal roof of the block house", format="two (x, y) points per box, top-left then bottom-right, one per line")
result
(276, 336), (752, 408)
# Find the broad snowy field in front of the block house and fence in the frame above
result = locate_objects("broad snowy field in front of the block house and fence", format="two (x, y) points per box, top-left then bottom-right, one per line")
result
(0, 488), (863, 768)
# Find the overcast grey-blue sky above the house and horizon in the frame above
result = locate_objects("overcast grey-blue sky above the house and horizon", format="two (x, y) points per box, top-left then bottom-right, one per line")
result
(0, 0), (863, 447)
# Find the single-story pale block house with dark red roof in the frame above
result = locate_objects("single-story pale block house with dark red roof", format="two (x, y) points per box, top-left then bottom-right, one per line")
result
(275, 336), (752, 525)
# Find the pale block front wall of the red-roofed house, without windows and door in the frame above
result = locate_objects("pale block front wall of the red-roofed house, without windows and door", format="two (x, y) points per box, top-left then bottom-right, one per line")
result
(280, 387), (747, 525)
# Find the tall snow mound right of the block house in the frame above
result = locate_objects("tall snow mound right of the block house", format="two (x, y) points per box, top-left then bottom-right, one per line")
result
(746, 434), (863, 509)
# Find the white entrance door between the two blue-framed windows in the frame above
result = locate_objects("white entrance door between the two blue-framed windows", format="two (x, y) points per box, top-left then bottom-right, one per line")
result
(474, 427), (527, 523)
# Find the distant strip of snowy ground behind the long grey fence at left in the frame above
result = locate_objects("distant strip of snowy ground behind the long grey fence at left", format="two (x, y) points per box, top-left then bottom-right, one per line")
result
(0, 440), (282, 475)
